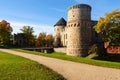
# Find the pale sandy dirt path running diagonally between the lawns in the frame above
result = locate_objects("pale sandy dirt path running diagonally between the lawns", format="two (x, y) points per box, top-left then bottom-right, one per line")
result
(0, 49), (120, 80)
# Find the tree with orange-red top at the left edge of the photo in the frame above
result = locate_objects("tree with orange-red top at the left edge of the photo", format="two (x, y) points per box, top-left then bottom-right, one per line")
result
(0, 20), (12, 46)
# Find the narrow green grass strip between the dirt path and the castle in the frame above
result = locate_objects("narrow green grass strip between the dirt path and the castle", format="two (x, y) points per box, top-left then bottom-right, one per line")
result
(13, 49), (120, 69)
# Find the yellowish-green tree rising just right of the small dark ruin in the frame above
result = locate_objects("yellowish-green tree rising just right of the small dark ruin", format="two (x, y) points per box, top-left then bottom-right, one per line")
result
(20, 26), (35, 46)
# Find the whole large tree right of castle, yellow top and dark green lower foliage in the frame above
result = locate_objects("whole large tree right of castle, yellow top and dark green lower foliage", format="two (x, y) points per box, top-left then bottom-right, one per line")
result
(94, 9), (120, 44)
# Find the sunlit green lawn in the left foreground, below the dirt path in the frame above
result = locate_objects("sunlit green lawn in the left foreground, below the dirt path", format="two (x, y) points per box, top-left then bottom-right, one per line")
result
(0, 52), (65, 80)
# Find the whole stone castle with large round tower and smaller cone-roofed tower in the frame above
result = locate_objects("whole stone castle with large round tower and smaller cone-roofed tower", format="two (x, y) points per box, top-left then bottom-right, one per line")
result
(54, 4), (102, 56)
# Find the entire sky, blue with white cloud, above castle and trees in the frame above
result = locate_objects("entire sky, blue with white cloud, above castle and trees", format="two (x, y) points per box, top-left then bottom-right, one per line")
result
(0, 0), (120, 35)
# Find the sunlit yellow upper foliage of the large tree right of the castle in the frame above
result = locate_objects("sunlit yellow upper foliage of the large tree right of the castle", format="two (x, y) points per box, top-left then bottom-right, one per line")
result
(94, 9), (120, 33)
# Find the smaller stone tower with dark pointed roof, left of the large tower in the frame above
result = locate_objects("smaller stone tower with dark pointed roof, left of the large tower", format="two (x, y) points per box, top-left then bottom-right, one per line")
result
(54, 18), (66, 47)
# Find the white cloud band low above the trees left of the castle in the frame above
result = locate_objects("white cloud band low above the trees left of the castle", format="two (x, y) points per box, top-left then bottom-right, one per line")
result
(8, 21), (54, 35)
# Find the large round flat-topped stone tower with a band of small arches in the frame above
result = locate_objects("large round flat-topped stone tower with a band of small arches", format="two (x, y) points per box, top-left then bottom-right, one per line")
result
(67, 4), (91, 56)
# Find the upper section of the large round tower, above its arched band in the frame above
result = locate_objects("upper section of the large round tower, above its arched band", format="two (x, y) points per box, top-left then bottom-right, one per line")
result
(68, 4), (91, 22)
